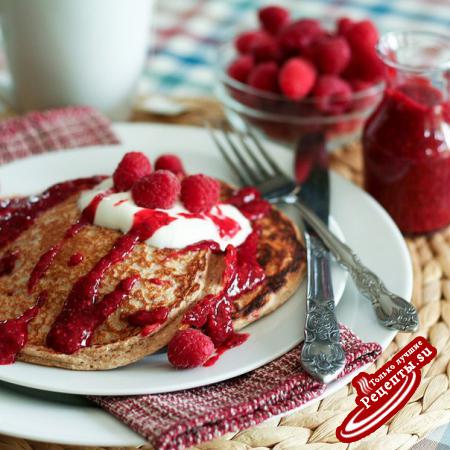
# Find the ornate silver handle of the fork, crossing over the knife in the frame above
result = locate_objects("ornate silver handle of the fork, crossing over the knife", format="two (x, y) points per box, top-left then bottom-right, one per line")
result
(289, 199), (419, 332)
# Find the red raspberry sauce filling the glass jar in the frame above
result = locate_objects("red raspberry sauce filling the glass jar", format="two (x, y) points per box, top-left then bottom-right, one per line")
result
(363, 82), (450, 233)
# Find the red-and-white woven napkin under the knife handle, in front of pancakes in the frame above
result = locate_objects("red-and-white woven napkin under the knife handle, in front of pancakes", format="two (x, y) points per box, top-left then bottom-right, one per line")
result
(92, 326), (381, 450)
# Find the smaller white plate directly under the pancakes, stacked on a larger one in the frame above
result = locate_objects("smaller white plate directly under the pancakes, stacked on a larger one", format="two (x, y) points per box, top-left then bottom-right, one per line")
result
(0, 127), (347, 395)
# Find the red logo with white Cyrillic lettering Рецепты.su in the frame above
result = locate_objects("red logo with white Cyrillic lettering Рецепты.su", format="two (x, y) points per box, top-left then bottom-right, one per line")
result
(336, 337), (437, 443)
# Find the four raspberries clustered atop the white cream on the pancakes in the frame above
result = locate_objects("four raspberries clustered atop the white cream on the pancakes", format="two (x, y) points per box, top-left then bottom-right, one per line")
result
(113, 152), (220, 214)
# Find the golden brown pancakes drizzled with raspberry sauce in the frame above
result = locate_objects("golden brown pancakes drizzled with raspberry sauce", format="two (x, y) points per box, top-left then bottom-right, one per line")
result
(0, 179), (305, 370)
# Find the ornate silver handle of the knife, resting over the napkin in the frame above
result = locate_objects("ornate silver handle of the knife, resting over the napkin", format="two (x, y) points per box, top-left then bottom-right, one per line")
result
(301, 232), (345, 383)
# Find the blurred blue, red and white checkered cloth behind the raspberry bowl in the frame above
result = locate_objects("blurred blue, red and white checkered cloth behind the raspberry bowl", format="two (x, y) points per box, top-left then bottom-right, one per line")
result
(146, 0), (450, 95)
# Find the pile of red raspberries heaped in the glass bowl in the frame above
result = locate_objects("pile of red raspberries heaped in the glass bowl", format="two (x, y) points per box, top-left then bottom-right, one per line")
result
(227, 6), (385, 115)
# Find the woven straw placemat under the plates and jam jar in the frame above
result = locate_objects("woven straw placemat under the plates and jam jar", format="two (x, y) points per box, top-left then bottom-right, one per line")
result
(0, 99), (450, 450)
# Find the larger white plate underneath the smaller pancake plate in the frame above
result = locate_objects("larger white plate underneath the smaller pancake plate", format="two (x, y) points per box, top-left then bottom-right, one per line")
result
(0, 124), (412, 446)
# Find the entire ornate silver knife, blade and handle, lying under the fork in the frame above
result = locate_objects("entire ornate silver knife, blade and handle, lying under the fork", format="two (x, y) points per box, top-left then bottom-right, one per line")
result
(297, 133), (345, 383)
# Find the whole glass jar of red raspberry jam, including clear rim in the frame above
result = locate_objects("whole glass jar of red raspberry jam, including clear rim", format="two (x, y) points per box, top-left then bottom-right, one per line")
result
(363, 32), (450, 234)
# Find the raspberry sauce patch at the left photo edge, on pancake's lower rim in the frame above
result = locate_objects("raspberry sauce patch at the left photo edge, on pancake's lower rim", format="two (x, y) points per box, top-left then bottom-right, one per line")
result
(0, 291), (47, 365)
